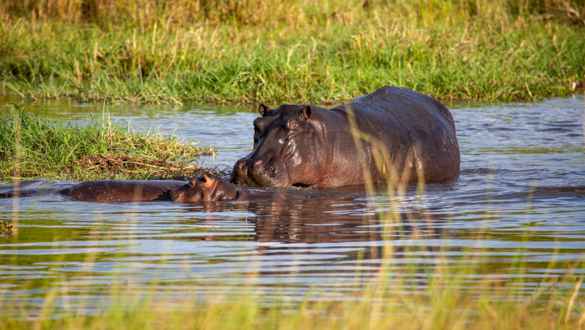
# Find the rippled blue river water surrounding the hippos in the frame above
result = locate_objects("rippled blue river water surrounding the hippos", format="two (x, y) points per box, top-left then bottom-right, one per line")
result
(0, 96), (585, 315)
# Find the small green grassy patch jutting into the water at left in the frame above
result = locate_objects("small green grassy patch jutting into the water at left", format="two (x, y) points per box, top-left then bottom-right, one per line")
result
(0, 105), (210, 180)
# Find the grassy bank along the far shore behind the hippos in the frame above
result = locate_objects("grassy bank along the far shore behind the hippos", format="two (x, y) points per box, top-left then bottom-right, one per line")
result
(0, 0), (585, 103)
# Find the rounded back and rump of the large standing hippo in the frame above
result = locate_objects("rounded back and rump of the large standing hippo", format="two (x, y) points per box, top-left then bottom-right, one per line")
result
(331, 86), (461, 181)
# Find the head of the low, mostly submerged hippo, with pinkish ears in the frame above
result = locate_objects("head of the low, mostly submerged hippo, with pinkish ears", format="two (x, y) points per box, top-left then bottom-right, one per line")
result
(170, 171), (238, 203)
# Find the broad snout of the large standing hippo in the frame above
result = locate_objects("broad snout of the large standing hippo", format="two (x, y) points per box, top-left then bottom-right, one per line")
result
(230, 157), (290, 187)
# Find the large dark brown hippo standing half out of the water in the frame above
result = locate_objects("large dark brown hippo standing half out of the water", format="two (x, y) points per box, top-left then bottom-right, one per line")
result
(231, 86), (461, 187)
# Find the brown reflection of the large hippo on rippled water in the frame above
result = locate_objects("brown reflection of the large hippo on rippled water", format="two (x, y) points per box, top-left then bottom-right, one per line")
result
(177, 185), (445, 266)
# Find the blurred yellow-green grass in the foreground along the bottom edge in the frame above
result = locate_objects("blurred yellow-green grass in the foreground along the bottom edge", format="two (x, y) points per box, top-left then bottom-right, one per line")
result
(0, 226), (585, 329)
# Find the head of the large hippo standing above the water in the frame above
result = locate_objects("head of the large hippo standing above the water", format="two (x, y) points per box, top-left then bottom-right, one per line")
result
(231, 104), (325, 187)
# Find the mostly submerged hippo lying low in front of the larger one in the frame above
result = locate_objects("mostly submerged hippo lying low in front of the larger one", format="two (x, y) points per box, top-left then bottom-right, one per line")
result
(0, 171), (306, 203)
